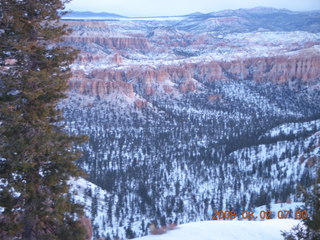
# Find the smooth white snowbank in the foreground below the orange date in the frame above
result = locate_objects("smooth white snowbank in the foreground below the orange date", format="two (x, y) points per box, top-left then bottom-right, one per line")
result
(137, 219), (299, 240)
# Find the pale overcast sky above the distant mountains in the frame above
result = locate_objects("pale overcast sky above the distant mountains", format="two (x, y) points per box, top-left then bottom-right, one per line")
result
(67, 0), (320, 17)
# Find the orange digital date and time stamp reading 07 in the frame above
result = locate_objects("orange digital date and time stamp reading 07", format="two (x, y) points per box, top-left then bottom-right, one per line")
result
(212, 210), (308, 220)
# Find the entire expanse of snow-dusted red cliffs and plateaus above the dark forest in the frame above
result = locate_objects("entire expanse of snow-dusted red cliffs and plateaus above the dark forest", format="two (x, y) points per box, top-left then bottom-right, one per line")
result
(65, 16), (320, 100)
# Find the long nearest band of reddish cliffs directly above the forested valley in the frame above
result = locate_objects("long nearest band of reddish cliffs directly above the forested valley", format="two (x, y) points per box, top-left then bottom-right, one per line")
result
(70, 55), (320, 99)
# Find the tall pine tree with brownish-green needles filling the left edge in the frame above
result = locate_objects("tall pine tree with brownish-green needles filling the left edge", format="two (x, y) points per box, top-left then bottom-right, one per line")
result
(0, 0), (85, 240)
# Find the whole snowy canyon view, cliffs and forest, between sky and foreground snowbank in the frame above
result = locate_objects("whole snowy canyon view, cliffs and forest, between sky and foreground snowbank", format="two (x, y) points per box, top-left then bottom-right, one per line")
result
(61, 8), (320, 239)
